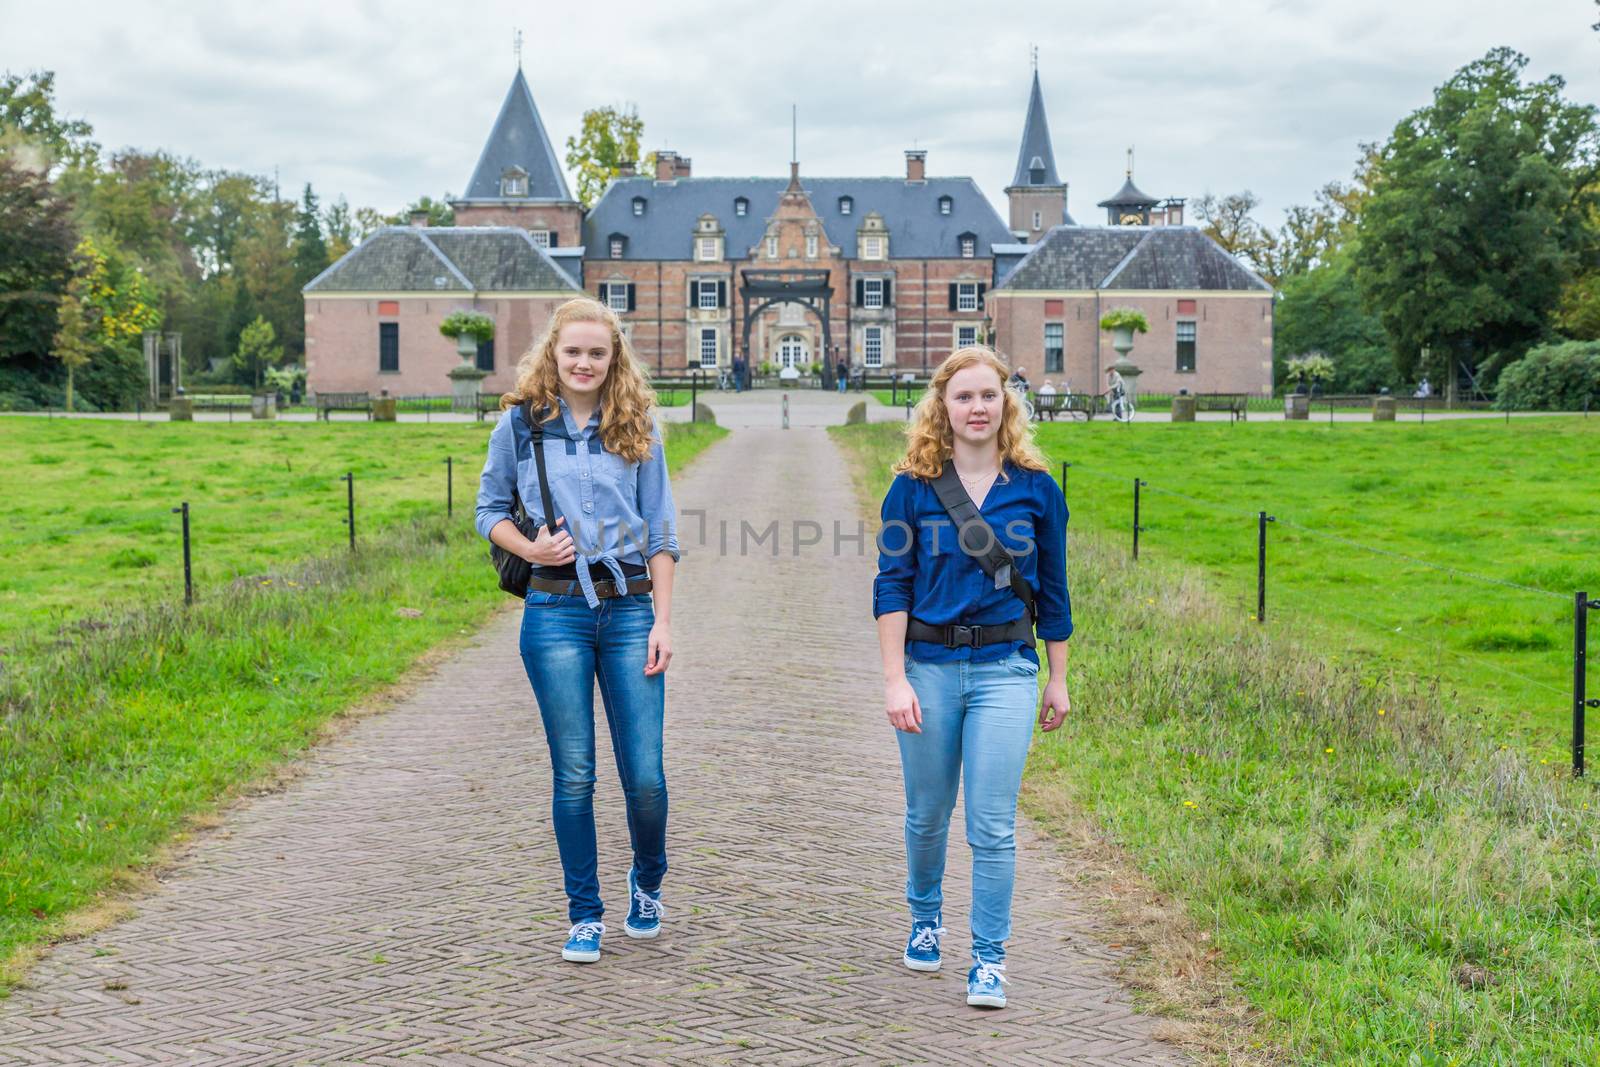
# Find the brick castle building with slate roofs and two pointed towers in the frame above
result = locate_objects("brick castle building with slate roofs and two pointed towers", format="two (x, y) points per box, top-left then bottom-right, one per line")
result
(304, 69), (1272, 395)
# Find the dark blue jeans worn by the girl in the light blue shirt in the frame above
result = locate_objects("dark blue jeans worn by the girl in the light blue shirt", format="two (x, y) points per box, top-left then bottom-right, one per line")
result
(522, 590), (667, 923)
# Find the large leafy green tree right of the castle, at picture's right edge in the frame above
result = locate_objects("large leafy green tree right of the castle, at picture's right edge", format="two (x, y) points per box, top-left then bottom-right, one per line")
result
(1355, 48), (1597, 379)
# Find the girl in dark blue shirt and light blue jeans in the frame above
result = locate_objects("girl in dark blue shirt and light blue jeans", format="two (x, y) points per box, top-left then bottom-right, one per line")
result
(872, 347), (1072, 1008)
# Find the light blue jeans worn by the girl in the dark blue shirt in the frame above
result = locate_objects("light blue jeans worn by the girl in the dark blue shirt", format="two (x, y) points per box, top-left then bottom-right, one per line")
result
(896, 653), (1038, 963)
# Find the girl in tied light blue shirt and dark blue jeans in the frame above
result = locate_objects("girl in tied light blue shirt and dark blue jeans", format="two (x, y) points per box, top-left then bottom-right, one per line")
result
(477, 298), (678, 963)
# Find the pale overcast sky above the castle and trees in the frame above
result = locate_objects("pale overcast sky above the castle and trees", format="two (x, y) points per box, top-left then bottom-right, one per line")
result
(0, 0), (1600, 224)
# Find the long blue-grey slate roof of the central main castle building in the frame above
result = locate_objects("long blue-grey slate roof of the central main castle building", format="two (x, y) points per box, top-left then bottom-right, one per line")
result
(584, 178), (1013, 259)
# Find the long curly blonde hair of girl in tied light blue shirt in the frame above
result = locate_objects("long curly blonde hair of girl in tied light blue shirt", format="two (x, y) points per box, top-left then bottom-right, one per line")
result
(501, 296), (656, 462)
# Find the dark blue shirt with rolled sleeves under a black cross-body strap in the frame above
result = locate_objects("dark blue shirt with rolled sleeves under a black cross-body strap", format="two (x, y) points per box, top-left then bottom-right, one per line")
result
(872, 462), (1072, 662)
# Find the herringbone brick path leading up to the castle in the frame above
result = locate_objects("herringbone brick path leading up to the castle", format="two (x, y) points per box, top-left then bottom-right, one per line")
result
(0, 429), (1186, 1065)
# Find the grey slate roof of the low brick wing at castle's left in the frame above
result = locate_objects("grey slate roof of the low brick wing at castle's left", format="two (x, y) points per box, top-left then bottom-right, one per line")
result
(302, 226), (578, 296)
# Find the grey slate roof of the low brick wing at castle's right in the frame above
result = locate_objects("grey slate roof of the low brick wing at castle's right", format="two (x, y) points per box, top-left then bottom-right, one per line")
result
(1000, 226), (1272, 293)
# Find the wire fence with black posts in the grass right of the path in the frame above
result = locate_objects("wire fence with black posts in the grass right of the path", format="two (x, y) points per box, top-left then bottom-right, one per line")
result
(1061, 461), (1600, 777)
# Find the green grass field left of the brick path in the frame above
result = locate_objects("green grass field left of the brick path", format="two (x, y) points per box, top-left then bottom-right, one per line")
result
(0, 419), (726, 992)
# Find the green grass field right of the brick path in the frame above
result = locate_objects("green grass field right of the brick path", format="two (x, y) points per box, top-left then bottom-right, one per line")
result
(835, 421), (1600, 1067)
